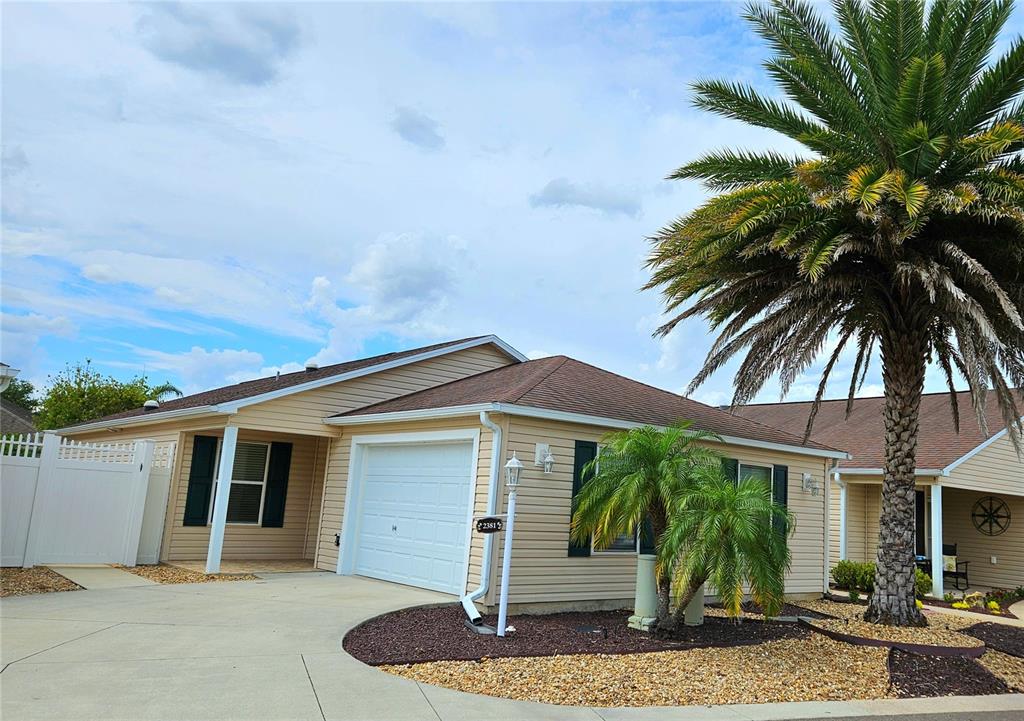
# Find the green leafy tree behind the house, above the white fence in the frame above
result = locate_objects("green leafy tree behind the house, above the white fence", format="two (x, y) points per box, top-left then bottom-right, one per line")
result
(33, 361), (181, 429)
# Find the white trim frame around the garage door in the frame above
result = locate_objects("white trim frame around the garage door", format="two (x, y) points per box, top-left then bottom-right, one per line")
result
(335, 427), (480, 594)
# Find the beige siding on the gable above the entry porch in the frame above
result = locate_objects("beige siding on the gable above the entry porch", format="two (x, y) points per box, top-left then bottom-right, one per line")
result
(231, 345), (513, 436)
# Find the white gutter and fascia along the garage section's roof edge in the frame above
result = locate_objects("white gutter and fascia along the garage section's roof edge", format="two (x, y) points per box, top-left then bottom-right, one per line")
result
(324, 402), (850, 459)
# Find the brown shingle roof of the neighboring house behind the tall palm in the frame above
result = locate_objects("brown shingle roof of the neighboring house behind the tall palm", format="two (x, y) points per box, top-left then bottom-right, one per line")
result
(734, 391), (1019, 470)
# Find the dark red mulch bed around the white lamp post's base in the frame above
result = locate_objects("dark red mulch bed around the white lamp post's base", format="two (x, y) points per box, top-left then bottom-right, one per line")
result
(342, 606), (809, 666)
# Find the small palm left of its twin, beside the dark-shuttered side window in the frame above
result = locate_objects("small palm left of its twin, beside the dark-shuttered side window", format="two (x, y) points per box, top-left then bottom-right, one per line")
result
(569, 421), (721, 625)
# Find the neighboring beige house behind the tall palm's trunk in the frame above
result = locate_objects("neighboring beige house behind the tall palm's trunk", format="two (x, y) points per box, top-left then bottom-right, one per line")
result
(735, 392), (1024, 595)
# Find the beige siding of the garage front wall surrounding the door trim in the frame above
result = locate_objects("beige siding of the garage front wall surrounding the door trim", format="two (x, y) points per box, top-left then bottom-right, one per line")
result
(316, 416), (501, 588)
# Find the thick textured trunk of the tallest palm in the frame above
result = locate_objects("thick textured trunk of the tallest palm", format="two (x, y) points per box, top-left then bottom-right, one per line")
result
(864, 329), (928, 626)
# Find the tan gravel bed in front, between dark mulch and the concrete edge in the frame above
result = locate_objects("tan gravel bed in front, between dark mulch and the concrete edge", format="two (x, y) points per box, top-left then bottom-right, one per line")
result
(382, 634), (893, 716)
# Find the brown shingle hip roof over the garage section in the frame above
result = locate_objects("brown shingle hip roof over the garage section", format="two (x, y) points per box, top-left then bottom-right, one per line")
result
(335, 355), (836, 451)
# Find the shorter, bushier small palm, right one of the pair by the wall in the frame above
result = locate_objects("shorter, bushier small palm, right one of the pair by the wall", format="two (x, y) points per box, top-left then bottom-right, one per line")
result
(660, 466), (793, 623)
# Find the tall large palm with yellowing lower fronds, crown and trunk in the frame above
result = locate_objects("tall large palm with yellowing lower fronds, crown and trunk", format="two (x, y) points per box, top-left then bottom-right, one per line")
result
(647, 0), (1024, 625)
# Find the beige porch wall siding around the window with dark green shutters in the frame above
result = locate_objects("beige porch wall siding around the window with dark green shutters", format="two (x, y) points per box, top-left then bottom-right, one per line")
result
(164, 428), (326, 561)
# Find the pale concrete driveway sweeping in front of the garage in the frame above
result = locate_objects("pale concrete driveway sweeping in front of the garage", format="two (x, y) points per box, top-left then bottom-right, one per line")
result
(0, 574), (1024, 721)
